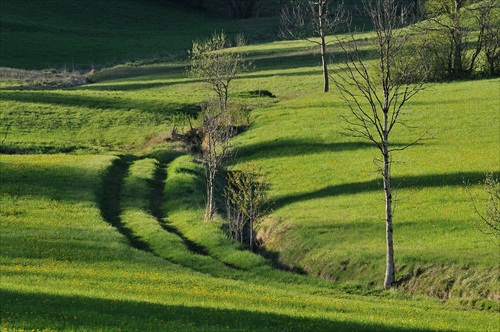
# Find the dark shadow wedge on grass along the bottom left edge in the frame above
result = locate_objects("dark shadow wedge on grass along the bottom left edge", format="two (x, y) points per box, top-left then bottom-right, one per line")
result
(1, 290), (434, 331)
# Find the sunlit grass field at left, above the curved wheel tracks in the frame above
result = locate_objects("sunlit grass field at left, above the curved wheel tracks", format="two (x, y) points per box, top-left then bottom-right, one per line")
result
(0, 69), (198, 151)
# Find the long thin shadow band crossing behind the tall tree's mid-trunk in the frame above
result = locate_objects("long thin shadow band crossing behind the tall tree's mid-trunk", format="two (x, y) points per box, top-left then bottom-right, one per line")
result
(273, 172), (500, 208)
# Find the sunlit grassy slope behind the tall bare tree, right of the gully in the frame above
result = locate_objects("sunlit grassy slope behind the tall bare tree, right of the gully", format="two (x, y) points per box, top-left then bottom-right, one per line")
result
(232, 63), (500, 296)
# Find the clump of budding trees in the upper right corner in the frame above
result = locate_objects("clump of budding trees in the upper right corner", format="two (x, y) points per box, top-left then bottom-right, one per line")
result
(418, 0), (500, 80)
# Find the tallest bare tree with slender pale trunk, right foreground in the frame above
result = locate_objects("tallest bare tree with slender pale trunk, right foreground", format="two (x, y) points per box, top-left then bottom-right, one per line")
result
(332, 0), (426, 288)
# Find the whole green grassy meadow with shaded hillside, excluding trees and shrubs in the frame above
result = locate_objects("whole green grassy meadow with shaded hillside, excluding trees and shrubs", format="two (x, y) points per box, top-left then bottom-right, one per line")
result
(0, 0), (500, 331)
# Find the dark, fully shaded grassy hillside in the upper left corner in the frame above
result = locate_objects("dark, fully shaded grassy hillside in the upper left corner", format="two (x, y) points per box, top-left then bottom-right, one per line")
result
(0, 0), (273, 69)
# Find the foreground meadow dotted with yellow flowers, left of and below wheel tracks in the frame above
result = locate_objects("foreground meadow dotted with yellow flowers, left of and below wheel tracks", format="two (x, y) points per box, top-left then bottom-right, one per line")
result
(0, 155), (497, 331)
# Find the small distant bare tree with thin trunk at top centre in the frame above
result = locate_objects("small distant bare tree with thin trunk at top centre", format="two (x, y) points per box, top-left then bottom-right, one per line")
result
(281, 0), (346, 92)
